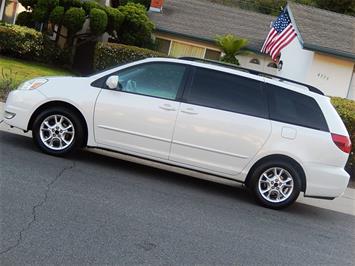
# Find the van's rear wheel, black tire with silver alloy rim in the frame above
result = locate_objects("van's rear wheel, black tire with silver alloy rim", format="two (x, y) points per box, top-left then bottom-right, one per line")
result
(250, 161), (302, 210)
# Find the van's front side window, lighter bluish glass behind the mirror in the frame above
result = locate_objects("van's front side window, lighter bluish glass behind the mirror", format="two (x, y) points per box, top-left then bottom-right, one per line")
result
(118, 63), (186, 100)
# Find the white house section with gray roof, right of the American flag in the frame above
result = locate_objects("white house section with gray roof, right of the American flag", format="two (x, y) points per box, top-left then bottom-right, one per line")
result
(278, 2), (355, 100)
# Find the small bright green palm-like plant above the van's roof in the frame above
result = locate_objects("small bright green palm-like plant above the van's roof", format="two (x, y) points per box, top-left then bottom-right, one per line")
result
(215, 34), (251, 65)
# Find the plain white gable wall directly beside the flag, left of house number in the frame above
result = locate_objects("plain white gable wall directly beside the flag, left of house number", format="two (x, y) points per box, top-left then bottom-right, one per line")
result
(278, 38), (314, 82)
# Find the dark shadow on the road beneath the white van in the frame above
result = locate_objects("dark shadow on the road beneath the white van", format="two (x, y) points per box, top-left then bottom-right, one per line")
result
(0, 132), (350, 221)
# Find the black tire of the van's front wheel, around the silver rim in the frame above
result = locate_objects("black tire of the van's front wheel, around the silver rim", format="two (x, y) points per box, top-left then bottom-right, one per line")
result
(32, 107), (84, 156)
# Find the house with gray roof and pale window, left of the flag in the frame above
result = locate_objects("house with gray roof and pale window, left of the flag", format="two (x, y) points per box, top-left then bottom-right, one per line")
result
(149, 0), (277, 74)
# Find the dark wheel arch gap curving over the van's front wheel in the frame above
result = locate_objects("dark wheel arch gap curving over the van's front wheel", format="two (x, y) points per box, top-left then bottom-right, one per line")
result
(27, 101), (89, 148)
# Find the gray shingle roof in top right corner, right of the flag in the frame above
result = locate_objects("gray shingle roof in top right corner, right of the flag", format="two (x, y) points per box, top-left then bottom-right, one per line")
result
(288, 2), (355, 59)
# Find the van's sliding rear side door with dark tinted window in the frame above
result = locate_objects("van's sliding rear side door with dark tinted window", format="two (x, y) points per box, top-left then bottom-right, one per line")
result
(170, 68), (271, 176)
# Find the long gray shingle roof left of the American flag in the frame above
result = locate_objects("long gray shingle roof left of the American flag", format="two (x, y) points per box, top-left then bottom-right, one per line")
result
(149, 0), (275, 51)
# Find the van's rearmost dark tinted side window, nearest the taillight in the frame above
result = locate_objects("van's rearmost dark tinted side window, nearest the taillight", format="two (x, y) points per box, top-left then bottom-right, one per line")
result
(265, 84), (329, 131)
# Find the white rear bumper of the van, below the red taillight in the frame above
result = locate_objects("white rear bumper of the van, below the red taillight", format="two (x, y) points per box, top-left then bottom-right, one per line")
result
(304, 163), (350, 199)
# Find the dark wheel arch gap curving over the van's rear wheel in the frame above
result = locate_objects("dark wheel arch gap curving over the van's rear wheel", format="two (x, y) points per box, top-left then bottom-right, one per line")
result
(244, 154), (307, 192)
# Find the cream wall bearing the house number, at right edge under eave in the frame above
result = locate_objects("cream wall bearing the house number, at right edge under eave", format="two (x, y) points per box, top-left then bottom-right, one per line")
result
(306, 53), (355, 98)
